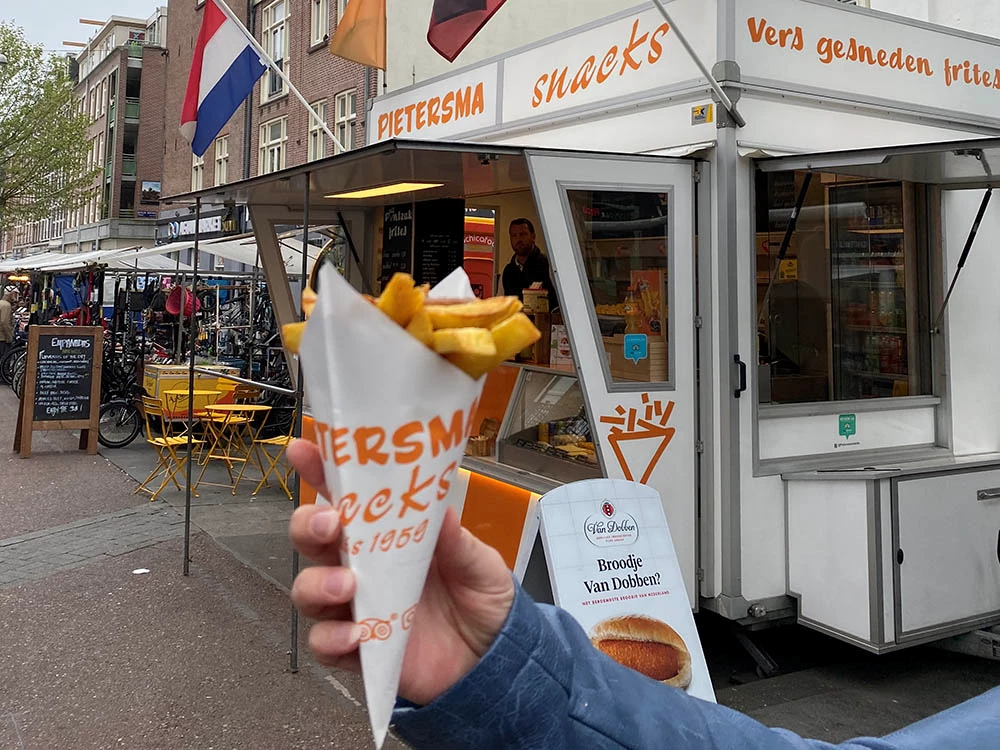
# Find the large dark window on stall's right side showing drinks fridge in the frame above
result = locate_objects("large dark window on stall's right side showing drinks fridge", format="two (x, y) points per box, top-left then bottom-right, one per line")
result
(754, 171), (932, 404)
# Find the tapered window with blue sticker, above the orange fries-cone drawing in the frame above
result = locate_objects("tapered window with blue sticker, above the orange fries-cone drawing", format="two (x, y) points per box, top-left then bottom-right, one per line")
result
(566, 189), (672, 386)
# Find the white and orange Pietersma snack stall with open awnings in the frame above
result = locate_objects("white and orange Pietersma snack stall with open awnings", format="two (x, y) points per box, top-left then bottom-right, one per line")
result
(168, 0), (1000, 653)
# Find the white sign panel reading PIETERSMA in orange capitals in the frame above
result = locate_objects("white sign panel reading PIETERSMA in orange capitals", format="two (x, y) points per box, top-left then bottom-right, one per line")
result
(369, 63), (499, 142)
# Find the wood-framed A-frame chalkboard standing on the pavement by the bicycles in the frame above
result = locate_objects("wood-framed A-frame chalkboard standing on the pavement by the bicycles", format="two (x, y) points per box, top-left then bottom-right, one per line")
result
(14, 326), (104, 458)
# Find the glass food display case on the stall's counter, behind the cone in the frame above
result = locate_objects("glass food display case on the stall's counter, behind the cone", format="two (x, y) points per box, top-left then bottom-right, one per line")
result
(497, 368), (602, 482)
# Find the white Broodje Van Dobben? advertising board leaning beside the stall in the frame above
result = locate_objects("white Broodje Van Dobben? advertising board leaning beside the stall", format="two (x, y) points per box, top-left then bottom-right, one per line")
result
(539, 479), (715, 701)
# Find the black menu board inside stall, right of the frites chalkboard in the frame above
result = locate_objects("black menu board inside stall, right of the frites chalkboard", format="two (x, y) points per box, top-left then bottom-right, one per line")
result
(413, 199), (465, 286)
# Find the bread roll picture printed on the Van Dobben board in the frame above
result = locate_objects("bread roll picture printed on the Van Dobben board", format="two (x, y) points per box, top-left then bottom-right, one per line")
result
(590, 615), (691, 688)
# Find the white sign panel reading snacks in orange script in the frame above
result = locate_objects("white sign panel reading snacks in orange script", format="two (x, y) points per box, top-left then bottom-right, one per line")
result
(503, 3), (715, 123)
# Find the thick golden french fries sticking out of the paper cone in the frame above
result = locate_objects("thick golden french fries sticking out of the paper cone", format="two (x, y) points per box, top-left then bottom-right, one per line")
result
(282, 273), (541, 378)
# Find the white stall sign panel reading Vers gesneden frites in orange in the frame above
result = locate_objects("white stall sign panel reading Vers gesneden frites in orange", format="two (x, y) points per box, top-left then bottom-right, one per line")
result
(736, 0), (1000, 125)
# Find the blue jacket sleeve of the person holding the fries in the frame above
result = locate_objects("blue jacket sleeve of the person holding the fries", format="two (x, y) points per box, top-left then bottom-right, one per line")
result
(393, 587), (1000, 750)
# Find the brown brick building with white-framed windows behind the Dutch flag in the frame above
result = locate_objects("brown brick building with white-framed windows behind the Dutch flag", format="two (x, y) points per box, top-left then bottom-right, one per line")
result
(161, 0), (378, 207)
